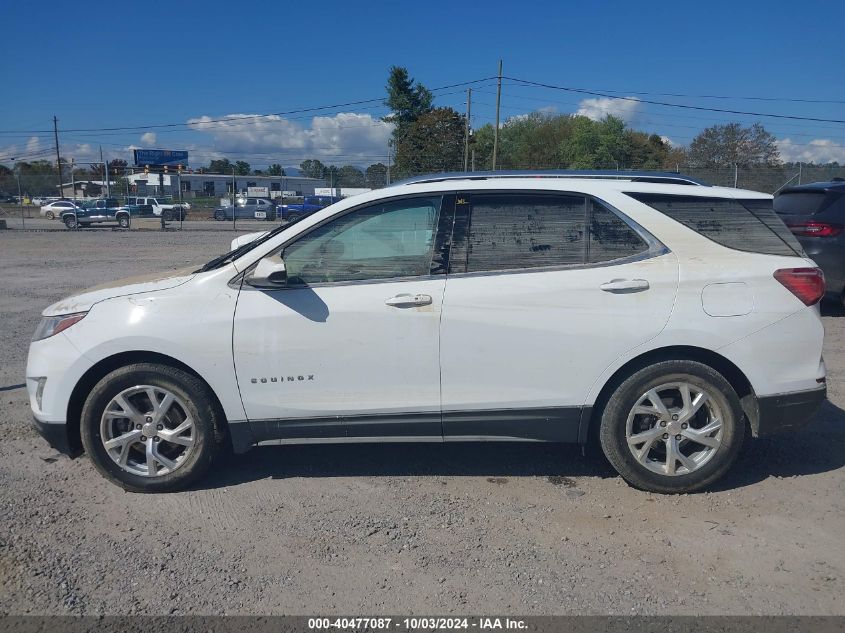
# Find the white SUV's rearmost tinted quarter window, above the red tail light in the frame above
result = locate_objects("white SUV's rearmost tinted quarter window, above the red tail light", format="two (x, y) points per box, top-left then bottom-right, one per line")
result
(627, 193), (803, 255)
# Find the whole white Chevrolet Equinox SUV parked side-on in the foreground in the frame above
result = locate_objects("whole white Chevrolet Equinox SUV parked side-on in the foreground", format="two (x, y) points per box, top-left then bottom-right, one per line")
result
(26, 172), (826, 493)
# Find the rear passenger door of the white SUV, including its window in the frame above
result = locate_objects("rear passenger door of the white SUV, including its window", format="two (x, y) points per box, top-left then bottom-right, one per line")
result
(441, 192), (678, 441)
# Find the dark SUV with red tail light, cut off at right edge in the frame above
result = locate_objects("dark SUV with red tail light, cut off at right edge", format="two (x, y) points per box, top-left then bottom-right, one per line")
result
(775, 178), (845, 303)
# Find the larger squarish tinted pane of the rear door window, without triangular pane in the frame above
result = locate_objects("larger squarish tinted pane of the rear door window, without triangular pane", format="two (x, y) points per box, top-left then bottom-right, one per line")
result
(467, 193), (587, 272)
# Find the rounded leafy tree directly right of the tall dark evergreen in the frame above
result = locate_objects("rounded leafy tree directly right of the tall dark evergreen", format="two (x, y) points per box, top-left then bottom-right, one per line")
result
(396, 108), (464, 177)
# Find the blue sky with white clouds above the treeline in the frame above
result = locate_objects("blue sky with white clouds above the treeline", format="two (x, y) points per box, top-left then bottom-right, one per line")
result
(0, 0), (845, 166)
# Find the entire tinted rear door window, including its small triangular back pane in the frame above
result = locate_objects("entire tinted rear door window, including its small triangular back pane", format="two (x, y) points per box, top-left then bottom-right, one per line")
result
(462, 193), (648, 272)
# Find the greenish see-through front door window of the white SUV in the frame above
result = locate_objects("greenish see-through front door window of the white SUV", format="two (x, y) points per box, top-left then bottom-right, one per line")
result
(282, 196), (442, 285)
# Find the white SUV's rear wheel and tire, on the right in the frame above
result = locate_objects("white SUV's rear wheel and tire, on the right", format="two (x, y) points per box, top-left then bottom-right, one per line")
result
(599, 360), (745, 494)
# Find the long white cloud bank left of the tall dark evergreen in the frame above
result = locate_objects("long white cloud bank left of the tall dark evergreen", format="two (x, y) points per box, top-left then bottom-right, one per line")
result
(183, 112), (393, 165)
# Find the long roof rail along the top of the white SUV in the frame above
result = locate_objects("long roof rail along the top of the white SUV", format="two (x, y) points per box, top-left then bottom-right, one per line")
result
(391, 169), (710, 187)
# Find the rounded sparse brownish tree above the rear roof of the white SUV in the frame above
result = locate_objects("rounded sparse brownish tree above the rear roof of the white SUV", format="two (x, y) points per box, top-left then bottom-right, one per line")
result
(687, 123), (781, 167)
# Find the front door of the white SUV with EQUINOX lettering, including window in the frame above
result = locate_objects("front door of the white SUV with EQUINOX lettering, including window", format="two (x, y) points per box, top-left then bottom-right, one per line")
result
(233, 195), (452, 441)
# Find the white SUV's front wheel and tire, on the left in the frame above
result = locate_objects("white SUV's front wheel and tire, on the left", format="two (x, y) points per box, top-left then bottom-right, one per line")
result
(80, 363), (225, 492)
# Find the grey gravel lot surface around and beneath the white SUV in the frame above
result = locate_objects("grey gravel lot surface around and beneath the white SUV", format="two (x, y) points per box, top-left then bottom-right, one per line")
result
(0, 228), (845, 615)
